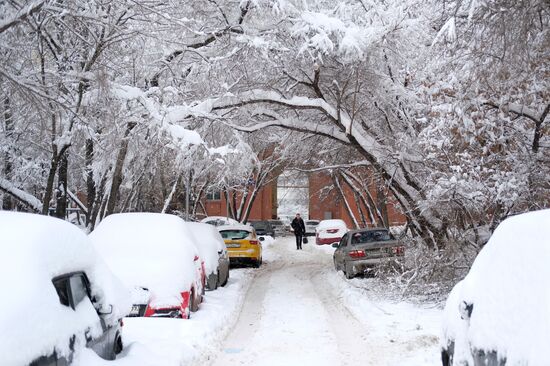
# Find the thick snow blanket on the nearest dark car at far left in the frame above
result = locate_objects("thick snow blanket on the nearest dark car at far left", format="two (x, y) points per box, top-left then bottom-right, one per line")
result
(0, 211), (131, 365)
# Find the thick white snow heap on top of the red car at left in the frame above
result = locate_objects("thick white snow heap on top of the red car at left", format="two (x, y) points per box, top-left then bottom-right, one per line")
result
(90, 213), (198, 307)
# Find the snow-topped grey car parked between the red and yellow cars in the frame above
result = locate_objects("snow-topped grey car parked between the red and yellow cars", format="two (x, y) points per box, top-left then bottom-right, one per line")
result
(186, 222), (229, 290)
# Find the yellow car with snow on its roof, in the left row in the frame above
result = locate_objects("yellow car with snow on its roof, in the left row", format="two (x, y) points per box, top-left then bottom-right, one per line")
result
(218, 225), (262, 268)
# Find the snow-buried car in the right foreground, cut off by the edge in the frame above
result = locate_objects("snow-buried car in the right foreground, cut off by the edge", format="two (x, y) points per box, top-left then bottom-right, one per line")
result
(440, 210), (550, 366)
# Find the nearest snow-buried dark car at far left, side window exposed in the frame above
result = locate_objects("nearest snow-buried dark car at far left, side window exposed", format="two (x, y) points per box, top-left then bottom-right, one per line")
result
(0, 211), (131, 366)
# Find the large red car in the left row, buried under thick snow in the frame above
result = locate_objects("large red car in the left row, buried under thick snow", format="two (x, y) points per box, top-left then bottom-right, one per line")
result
(89, 213), (205, 318)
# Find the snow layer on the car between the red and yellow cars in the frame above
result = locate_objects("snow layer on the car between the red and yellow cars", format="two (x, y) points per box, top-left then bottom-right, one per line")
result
(185, 222), (225, 276)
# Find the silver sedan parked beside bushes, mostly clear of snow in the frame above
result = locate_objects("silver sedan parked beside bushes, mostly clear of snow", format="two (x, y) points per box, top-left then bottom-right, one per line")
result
(332, 228), (405, 278)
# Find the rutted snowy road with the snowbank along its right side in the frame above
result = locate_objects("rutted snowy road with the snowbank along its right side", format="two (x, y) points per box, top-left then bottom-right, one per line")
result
(205, 238), (440, 366)
